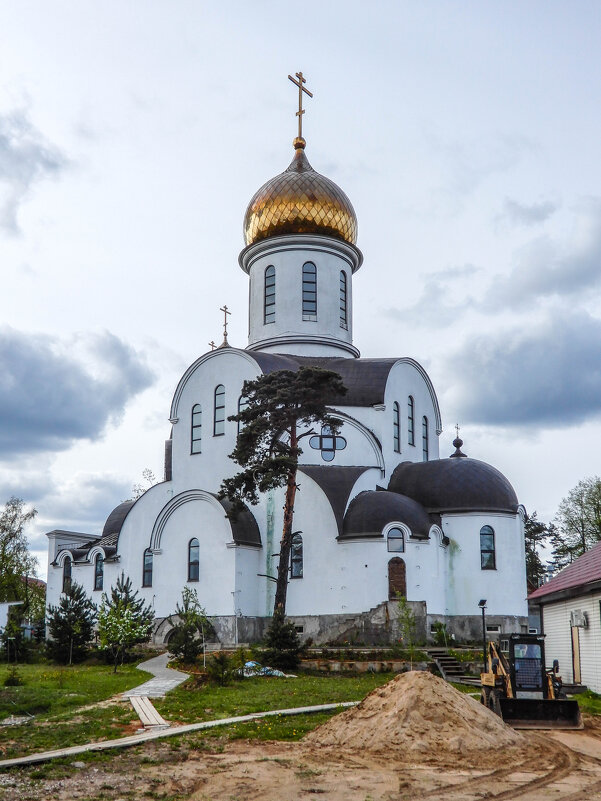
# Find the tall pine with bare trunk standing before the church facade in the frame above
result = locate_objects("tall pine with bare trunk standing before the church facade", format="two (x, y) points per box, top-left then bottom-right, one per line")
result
(220, 367), (346, 619)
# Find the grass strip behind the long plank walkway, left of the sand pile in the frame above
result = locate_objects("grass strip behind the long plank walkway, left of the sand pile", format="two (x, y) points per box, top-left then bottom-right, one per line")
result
(155, 673), (391, 723)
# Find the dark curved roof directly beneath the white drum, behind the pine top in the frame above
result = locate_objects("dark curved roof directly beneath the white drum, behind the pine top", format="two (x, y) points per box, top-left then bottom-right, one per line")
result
(250, 350), (398, 406)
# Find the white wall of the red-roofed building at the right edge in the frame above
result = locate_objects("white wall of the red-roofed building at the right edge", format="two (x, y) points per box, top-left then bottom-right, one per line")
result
(543, 592), (601, 693)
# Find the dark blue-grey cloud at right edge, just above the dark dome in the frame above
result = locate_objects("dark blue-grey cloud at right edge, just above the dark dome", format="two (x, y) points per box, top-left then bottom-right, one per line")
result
(446, 313), (601, 429)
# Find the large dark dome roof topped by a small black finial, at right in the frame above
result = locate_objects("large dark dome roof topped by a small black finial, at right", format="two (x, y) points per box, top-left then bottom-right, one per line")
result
(388, 457), (518, 514)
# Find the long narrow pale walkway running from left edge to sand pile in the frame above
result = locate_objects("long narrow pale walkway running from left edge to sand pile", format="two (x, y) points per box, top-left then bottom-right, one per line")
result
(0, 701), (359, 769)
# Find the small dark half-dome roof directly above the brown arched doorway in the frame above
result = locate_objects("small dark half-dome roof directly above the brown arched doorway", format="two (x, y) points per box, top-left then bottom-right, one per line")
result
(340, 490), (431, 539)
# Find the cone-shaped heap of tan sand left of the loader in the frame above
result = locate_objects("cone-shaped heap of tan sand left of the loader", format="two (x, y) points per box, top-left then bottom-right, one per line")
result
(305, 671), (524, 757)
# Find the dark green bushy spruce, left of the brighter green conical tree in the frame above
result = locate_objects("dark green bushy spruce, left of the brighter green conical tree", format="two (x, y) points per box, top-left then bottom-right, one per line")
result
(47, 581), (97, 665)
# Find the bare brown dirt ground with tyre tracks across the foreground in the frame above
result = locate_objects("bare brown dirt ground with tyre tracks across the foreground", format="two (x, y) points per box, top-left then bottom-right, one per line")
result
(0, 720), (601, 801)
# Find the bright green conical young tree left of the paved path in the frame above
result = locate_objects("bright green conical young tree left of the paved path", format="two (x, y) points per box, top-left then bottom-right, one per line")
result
(98, 573), (154, 673)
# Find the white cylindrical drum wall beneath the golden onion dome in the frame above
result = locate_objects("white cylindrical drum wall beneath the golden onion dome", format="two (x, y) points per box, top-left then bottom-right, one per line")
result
(247, 236), (357, 356)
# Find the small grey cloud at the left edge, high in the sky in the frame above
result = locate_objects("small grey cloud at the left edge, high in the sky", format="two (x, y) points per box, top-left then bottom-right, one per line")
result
(0, 111), (67, 234)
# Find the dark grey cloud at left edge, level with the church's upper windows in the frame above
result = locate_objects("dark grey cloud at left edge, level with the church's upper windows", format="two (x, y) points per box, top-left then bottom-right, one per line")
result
(0, 328), (153, 459)
